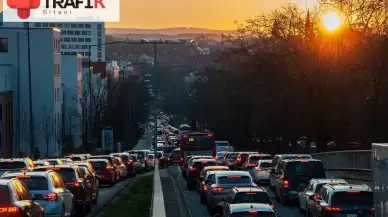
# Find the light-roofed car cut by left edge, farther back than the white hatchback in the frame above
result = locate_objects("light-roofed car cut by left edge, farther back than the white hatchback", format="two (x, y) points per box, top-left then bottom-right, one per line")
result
(0, 157), (35, 176)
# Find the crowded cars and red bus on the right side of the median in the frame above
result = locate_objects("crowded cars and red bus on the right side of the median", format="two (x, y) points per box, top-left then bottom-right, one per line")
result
(157, 122), (374, 217)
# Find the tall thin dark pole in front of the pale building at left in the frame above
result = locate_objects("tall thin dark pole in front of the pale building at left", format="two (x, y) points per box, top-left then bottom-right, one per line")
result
(26, 22), (35, 154)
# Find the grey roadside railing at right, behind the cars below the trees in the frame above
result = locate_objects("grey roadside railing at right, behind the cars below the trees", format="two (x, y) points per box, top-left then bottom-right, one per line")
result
(312, 150), (372, 172)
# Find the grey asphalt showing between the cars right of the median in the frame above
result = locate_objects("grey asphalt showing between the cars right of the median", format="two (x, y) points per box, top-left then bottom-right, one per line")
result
(168, 166), (372, 217)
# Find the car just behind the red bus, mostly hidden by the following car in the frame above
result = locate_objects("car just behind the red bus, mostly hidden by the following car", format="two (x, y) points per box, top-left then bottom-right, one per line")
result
(186, 159), (217, 190)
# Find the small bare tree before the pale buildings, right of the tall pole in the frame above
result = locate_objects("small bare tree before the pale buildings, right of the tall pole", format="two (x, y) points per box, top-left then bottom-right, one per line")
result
(38, 107), (54, 157)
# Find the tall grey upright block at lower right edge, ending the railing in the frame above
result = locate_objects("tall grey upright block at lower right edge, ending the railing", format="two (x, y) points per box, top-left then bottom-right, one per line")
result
(372, 143), (388, 217)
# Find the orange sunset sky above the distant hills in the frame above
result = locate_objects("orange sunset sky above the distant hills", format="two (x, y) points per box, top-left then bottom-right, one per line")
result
(0, 0), (315, 30)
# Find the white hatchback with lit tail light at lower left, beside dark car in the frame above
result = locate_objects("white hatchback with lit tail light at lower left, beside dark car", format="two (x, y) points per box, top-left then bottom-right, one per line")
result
(1, 171), (75, 216)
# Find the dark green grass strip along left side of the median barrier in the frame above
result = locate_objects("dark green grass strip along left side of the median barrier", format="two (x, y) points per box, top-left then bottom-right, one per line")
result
(104, 175), (154, 217)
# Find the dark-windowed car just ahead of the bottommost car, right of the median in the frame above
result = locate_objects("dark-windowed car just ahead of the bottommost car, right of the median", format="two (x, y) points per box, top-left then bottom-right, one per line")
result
(218, 187), (276, 215)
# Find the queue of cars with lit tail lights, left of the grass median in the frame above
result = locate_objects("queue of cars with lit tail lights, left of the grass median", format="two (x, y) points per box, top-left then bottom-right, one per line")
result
(0, 150), (154, 217)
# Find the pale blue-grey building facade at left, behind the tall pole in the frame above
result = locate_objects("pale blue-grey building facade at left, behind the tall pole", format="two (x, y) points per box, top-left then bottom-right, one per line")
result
(0, 27), (62, 156)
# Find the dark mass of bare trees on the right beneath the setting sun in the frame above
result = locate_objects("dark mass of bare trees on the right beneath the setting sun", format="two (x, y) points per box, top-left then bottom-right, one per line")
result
(192, 0), (388, 151)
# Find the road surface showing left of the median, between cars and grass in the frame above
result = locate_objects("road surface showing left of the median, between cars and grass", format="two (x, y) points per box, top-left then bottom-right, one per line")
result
(87, 129), (152, 217)
